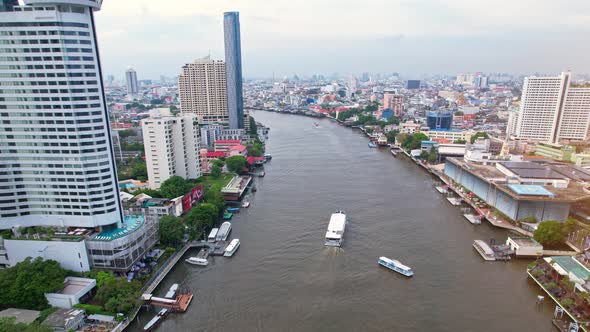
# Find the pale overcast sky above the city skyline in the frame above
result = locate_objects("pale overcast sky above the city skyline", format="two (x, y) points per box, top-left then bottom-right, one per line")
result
(96, 0), (590, 79)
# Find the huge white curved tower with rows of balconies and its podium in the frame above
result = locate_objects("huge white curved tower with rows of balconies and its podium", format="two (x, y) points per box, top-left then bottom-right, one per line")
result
(0, 0), (157, 271)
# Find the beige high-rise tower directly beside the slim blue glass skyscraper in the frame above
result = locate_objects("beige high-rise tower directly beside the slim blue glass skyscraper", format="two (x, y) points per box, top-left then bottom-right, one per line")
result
(178, 57), (229, 124)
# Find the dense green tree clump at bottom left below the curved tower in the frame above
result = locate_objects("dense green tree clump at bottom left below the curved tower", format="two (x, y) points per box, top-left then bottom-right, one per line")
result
(0, 257), (71, 310)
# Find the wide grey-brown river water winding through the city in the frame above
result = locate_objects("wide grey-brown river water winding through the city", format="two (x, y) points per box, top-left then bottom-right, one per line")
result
(130, 111), (553, 331)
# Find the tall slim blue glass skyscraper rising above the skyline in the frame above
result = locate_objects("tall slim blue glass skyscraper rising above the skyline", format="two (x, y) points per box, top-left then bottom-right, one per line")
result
(223, 12), (244, 129)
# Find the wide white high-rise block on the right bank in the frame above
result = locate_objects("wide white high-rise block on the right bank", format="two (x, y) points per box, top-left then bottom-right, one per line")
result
(508, 72), (590, 143)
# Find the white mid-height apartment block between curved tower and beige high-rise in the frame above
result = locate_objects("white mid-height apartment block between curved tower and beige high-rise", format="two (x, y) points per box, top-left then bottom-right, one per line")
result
(141, 113), (201, 189)
